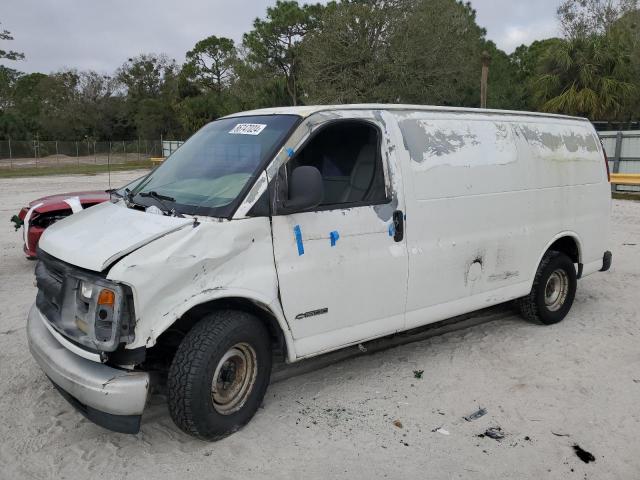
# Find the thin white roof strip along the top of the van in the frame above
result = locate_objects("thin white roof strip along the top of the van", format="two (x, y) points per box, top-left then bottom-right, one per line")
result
(226, 103), (589, 121)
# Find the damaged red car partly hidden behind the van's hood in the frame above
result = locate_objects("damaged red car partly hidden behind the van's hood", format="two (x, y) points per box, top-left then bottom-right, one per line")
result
(11, 179), (140, 259)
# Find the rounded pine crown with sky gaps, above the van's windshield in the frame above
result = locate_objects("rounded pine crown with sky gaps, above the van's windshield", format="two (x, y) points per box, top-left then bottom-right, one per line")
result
(184, 35), (237, 93)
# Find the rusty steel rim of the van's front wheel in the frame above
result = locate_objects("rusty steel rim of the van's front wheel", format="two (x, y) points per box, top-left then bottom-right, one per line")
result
(211, 343), (258, 415)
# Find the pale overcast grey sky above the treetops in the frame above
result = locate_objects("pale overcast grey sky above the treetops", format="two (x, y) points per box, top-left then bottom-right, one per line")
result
(0, 0), (560, 73)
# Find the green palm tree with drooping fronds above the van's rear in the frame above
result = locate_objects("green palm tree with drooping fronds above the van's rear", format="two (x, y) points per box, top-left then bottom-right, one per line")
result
(535, 35), (637, 120)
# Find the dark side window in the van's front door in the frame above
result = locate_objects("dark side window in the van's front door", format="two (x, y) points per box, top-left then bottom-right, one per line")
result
(287, 121), (387, 208)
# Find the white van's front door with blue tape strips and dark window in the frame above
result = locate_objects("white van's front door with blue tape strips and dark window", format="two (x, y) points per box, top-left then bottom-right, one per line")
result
(273, 111), (408, 356)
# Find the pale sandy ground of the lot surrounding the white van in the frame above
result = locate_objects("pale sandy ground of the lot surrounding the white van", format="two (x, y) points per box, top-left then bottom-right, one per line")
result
(0, 172), (640, 480)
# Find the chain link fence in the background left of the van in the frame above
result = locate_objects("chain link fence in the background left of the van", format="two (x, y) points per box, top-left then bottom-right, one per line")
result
(0, 140), (168, 170)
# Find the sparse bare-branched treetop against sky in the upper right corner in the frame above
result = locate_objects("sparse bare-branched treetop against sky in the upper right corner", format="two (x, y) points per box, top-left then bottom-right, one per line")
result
(558, 0), (638, 38)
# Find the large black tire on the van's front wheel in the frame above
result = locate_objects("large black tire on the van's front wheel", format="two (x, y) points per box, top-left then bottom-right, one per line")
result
(167, 310), (271, 441)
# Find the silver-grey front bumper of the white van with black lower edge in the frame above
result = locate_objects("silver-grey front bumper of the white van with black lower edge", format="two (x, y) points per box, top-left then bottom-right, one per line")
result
(27, 305), (150, 433)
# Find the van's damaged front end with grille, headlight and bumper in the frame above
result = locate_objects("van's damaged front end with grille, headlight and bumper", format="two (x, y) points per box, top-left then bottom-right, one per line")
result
(27, 250), (150, 433)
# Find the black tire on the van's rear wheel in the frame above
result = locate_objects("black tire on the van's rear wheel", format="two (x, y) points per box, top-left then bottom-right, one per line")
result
(517, 250), (578, 325)
